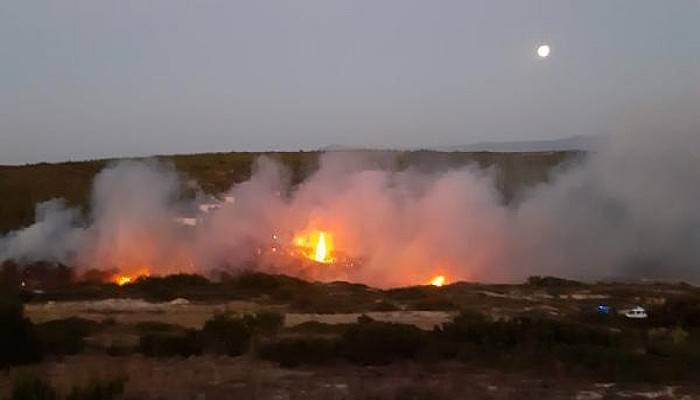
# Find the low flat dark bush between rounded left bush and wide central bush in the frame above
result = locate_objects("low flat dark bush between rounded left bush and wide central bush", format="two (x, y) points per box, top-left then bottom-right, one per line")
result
(258, 337), (337, 368)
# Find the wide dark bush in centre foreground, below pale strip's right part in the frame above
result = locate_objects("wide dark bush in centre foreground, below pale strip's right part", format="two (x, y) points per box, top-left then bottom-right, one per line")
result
(339, 321), (427, 365)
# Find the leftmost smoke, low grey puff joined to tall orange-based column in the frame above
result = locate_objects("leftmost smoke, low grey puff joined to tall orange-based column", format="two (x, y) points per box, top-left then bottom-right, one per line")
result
(0, 161), (194, 273)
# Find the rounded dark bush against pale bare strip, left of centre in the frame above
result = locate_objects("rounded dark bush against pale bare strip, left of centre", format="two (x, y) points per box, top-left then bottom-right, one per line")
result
(201, 314), (252, 356)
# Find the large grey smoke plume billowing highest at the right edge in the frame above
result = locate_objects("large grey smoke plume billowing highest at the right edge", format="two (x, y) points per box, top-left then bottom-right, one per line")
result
(511, 106), (700, 282)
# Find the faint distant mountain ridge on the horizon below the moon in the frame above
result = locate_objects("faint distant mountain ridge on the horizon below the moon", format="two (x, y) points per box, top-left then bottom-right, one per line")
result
(437, 135), (605, 152)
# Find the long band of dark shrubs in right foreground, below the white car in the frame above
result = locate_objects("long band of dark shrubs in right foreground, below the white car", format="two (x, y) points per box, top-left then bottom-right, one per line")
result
(258, 313), (700, 383)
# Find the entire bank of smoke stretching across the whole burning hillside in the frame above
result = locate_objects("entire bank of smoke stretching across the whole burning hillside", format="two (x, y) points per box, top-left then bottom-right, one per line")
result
(0, 109), (700, 287)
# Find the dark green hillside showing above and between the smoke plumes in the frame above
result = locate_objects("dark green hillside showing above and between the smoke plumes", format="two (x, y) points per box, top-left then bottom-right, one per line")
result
(0, 151), (583, 234)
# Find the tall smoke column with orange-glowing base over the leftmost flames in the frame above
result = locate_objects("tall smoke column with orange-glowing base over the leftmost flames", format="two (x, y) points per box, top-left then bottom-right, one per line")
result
(77, 161), (196, 273)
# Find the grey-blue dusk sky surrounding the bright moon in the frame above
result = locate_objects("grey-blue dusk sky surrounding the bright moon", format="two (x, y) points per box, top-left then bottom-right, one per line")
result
(0, 0), (700, 164)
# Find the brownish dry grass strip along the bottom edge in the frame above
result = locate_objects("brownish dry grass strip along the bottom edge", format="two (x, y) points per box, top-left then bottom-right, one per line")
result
(0, 355), (700, 400)
